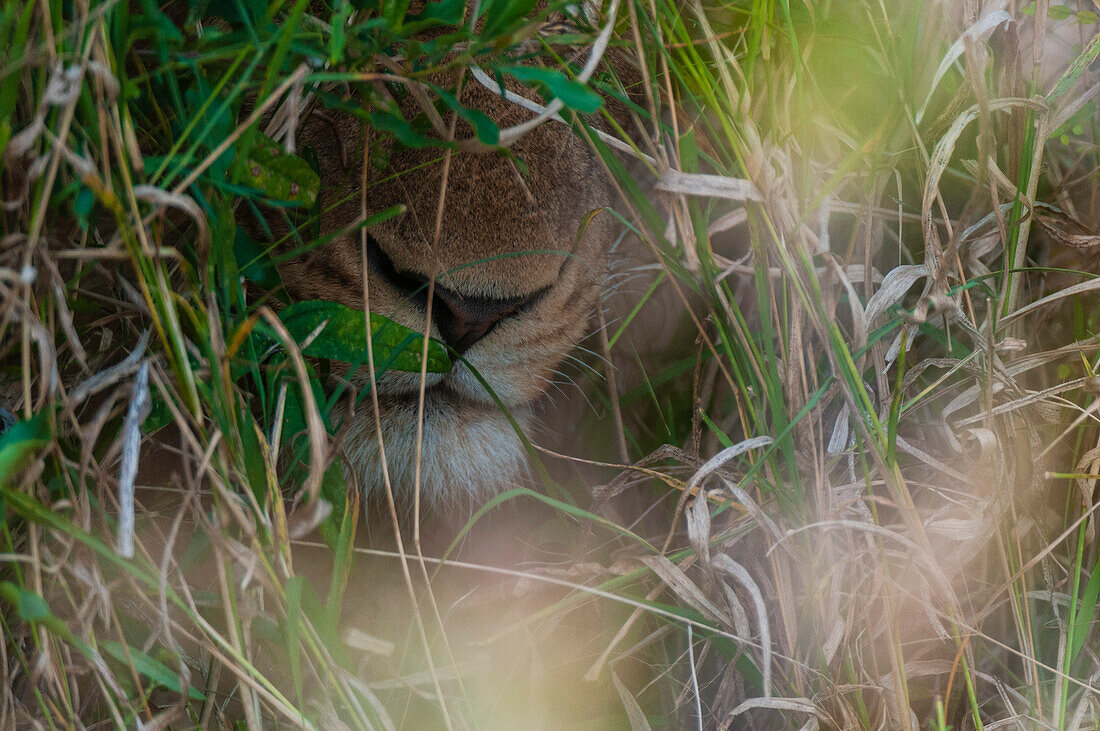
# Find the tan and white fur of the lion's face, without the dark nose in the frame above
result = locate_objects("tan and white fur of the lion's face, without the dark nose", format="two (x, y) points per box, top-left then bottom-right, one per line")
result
(256, 41), (638, 507)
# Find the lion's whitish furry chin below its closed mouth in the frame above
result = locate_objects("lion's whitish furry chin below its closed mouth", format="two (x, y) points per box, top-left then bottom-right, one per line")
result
(345, 388), (531, 511)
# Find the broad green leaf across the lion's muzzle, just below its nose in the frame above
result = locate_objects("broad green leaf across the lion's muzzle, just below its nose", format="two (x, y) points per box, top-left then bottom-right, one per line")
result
(279, 300), (451, 373)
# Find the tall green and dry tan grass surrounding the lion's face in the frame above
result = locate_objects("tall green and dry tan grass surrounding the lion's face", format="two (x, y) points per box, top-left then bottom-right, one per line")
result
(0, 0), (1100, 729)
